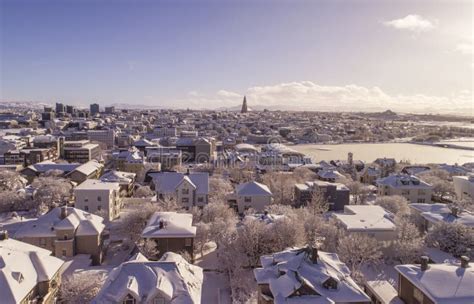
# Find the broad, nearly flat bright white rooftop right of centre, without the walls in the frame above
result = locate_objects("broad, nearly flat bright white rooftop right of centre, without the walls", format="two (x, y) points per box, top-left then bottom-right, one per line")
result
(334, 205), (395, 232)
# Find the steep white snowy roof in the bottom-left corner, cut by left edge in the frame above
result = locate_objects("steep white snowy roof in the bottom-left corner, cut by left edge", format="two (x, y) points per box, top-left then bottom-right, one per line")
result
(0, 238), (64, 304)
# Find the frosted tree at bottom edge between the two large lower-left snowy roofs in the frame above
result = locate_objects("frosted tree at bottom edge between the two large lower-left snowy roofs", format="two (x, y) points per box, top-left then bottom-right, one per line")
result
(59, 272), (105, 304)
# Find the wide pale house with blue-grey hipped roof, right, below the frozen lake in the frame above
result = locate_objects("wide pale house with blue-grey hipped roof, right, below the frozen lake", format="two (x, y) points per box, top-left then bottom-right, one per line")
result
(376, 174), (433, 203)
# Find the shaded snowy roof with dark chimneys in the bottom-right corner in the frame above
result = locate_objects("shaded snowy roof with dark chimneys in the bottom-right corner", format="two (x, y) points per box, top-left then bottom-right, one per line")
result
(395, 263), (474, 304)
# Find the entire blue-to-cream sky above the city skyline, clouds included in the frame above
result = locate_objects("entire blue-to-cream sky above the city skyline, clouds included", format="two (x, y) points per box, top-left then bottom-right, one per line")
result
(0, 0), (474, 115)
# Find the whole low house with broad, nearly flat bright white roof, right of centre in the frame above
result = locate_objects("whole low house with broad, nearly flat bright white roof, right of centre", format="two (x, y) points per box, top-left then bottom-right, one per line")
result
(333, 205), (397, 241)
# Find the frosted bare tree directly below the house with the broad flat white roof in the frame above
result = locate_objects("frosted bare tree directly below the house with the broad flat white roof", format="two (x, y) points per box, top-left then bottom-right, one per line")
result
(337, 233), (382, 272)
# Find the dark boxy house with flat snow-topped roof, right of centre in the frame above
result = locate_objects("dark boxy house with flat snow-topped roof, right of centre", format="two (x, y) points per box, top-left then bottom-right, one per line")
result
(294, 180), (350, 211)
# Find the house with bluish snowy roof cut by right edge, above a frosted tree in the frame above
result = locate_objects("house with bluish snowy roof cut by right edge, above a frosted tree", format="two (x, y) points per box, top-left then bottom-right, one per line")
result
(410, 203), (474, 231)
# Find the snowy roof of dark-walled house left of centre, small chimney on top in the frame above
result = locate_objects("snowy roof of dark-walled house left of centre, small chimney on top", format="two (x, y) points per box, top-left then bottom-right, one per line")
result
(142, 212), (196, 238)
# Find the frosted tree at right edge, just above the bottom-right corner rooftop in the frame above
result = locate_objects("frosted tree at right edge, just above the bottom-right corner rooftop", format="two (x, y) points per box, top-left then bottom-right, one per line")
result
(426, 222), (474, 258)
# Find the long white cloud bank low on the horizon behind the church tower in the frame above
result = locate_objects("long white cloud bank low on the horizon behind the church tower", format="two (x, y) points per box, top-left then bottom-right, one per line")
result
(173, 81), (473, 114)
